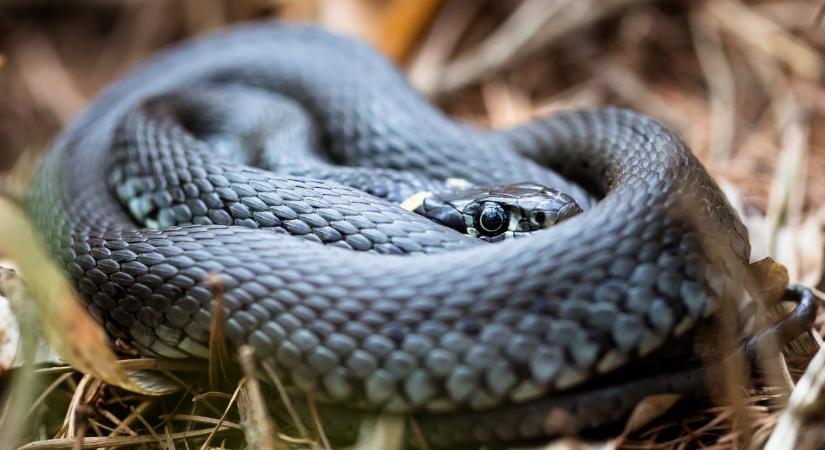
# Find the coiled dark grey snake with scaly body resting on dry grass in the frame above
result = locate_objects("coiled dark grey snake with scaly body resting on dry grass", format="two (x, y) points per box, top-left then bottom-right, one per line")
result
(29, 23), (768, 447)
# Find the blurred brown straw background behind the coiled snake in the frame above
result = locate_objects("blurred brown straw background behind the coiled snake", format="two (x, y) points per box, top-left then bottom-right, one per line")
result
(0, 0), (825, 448)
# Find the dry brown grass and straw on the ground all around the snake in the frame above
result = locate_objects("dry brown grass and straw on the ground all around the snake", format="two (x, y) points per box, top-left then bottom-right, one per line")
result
(0, 0), (825, 449)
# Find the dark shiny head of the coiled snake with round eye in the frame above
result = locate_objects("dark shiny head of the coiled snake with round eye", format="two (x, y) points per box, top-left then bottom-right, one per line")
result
(415, 183), (582, 242)
